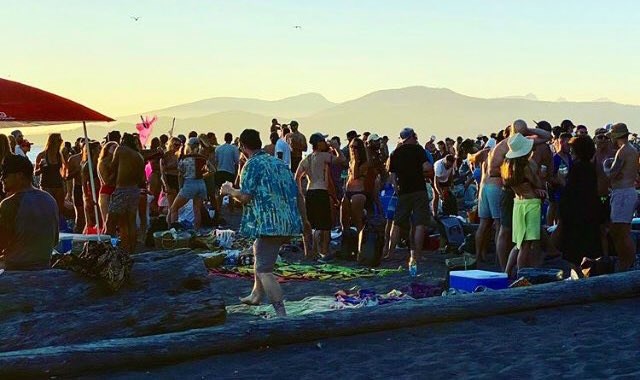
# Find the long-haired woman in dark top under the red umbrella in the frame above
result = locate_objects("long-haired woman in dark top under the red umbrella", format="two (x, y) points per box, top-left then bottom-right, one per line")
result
(35, 133), (66, 215)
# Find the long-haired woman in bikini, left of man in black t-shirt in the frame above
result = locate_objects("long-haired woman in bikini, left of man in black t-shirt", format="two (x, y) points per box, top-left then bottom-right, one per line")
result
(341, 137), (371, 246)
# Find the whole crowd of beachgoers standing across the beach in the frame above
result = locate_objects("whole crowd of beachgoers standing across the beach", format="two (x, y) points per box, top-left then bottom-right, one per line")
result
(0, 119), (639, 311)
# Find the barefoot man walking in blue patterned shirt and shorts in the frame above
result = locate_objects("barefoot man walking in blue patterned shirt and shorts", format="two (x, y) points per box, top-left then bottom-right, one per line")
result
(220, 129), (302, 316)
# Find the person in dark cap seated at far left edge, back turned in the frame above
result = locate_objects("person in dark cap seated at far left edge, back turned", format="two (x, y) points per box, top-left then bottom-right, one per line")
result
(0, 155), (59, 270)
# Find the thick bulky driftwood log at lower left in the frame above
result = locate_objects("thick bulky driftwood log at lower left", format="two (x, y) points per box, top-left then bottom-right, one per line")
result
(0, 251), (226, 352)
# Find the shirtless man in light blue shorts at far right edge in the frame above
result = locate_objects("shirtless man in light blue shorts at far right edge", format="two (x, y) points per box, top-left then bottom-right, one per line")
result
(603, 123), (639, 271)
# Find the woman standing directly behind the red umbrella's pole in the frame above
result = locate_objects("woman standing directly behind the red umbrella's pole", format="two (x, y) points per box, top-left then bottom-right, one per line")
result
(80, 141), (104, 233)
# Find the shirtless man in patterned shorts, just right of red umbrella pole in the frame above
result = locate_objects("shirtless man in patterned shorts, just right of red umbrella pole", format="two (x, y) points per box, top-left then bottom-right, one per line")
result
(107, 133), (145, 254)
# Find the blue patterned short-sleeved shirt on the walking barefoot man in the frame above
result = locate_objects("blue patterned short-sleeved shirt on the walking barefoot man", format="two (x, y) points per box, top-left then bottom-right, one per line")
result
(240, 151), (302, 238)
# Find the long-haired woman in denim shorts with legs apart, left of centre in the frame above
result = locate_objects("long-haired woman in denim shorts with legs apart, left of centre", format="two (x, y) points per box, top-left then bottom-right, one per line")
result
(167, 137), (207, 230)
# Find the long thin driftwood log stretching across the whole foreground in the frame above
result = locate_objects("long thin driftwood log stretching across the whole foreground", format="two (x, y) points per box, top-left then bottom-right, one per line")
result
(0, 271), (640, 377)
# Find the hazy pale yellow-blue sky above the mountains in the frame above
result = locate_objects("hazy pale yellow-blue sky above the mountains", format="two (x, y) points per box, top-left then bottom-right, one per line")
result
(5, 0), (640, 116)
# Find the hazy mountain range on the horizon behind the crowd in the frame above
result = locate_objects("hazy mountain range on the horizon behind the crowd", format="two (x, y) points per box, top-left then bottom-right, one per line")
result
(28, 86), (640, 143)
